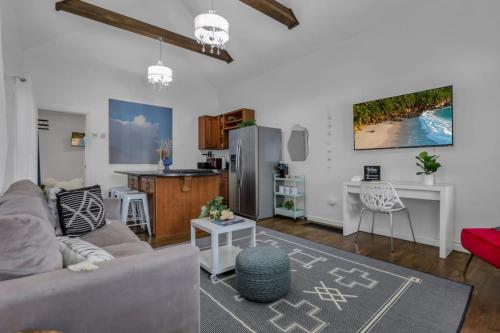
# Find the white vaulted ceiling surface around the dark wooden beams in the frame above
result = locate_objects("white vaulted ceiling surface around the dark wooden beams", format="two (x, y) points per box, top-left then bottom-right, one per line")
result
(11, 0), (434, 89)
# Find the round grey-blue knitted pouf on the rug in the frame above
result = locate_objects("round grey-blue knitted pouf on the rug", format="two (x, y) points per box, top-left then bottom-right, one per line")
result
(235, 246), (290, 302)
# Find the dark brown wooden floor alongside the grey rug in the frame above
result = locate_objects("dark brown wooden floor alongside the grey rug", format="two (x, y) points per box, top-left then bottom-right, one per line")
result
(142, 218), (500, 333)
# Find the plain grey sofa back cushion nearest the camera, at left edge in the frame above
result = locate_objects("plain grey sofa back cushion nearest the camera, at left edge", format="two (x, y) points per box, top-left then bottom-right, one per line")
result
(0, 213), (63, 281)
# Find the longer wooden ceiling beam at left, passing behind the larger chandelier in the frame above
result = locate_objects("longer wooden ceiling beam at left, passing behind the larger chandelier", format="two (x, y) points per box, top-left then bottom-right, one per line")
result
(56, 0), (233, 63)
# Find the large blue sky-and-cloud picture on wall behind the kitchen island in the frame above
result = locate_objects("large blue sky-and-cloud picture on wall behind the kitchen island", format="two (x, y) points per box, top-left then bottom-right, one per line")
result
(109, 99), (172, 164)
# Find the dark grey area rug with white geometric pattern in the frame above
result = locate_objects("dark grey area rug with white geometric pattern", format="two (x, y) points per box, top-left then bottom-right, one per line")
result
(197, 227), (472, 333)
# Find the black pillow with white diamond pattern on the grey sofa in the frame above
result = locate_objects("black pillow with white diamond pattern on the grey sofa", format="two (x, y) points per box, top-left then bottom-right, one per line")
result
(57, 185), (106, 237)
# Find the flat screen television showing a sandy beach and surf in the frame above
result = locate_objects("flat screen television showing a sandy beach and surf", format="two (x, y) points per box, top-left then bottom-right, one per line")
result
(353, 86), (453, 150)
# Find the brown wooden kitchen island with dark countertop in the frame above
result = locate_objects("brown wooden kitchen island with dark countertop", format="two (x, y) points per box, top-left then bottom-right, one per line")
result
(115, 169), (221, 242)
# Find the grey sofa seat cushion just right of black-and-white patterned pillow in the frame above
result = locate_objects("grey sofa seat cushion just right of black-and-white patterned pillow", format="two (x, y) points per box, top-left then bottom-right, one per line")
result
(80, 220), (140, 247)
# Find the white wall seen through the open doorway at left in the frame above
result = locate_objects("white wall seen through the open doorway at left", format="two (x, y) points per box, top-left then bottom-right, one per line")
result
(38, 110), (85, 183)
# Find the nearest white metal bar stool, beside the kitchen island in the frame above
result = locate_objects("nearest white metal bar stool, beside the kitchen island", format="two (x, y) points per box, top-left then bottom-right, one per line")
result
(120, 191), (151, 236)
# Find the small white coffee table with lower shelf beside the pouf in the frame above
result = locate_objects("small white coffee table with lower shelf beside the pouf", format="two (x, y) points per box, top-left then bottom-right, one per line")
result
(191, 216), (256, 281)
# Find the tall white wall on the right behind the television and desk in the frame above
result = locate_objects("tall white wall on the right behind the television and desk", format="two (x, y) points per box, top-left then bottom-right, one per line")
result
(219, 1), (500, 248)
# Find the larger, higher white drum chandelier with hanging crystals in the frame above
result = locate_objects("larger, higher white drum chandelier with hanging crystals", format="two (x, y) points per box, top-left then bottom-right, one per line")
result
(194, 0), (229, 54)
